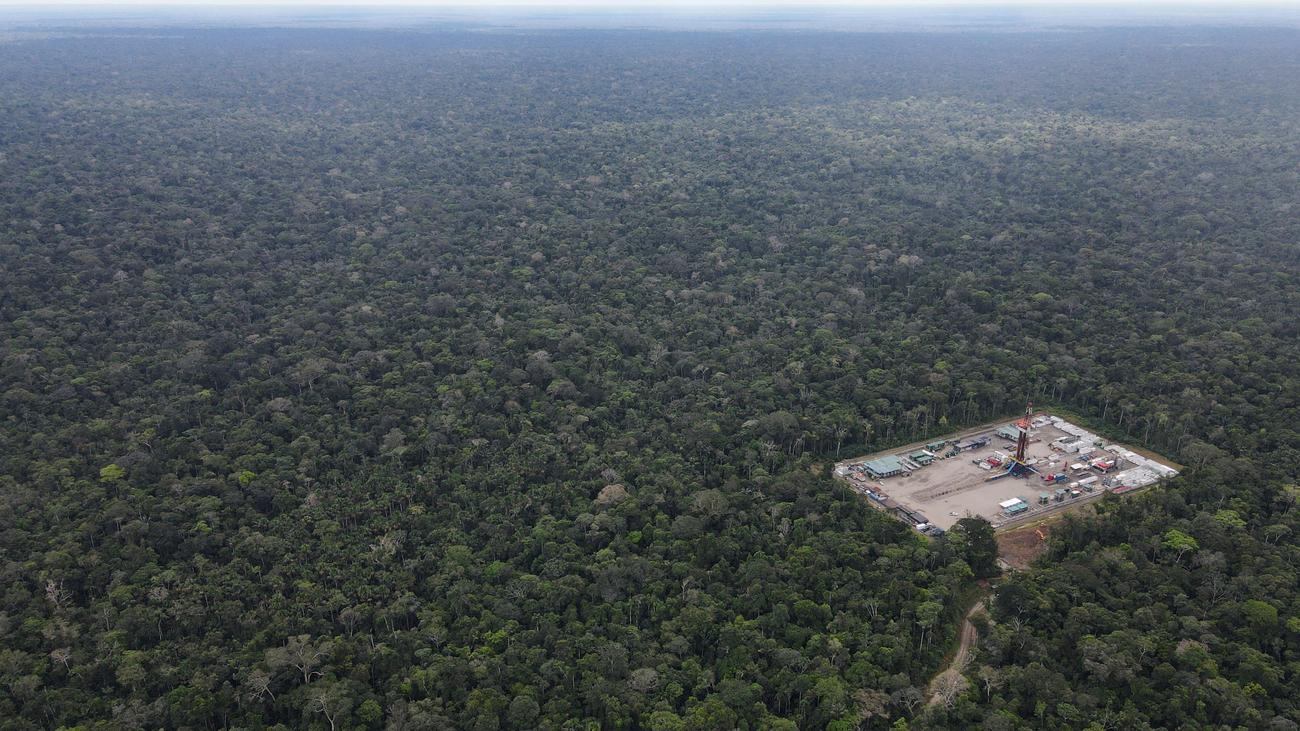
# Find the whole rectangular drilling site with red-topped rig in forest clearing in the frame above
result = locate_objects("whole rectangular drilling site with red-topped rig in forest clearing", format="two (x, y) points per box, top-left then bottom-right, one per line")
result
(835, 407), (1178, 536)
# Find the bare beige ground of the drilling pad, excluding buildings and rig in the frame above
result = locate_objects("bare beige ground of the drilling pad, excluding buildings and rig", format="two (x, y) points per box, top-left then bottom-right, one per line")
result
(836, 415), (1175, 531)
